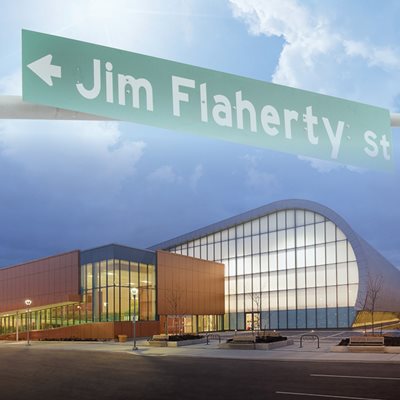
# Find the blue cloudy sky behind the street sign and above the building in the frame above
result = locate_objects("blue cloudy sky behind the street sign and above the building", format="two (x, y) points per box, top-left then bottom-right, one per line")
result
(0, 0), (400, 267)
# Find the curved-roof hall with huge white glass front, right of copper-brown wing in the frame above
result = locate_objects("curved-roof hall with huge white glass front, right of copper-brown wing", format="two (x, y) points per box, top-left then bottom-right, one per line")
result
(152, 200), (400, 330)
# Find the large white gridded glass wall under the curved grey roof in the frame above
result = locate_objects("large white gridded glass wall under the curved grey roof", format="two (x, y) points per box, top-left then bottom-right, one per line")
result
(168, 209), (358, 330)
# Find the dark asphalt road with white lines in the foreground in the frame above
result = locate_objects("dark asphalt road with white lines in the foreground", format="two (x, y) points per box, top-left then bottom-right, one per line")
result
(0, 347), (400, 400)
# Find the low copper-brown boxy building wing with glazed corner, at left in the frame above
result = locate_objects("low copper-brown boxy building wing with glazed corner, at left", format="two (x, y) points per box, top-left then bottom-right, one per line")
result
(0, 244), (224, 339)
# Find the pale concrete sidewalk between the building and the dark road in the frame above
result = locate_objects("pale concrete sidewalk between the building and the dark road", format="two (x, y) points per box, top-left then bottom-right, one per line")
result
(0, 338), (400, 363)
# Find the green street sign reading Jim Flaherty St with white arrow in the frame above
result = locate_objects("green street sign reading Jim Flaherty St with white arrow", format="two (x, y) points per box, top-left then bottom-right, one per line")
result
(22, 30), (393, 170)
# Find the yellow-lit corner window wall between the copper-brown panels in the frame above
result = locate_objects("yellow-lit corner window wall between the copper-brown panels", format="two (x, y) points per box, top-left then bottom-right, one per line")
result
(81, 259), (156, 322)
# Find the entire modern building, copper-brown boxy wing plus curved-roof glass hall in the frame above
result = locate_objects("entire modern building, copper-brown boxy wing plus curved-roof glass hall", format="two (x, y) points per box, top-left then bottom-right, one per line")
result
(0, 200), (400, 339)
